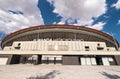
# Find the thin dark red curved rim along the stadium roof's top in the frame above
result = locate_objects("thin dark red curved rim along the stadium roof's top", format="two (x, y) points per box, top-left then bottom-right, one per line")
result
(1, 24), (119, 47)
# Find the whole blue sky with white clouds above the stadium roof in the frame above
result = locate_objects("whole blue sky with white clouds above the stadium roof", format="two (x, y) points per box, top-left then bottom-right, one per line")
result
(0, 0), (120, 43)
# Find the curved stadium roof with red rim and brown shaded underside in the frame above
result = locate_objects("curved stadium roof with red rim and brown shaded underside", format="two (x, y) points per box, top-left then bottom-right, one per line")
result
(1, 25), (119, 49)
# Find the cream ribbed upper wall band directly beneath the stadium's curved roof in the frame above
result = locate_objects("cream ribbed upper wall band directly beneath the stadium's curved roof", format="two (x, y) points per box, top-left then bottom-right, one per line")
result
(4, 41), (116, 51)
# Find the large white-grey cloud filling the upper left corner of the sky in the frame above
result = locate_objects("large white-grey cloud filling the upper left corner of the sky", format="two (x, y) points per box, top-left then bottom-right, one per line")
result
(0, 0), (43, 33)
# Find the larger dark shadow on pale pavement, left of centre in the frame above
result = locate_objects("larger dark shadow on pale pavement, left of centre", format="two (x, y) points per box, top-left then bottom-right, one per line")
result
(26, 70), (60, 79)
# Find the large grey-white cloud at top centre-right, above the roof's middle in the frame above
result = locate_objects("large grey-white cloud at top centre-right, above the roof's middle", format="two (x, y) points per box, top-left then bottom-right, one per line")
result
(47, 0), (106, 29)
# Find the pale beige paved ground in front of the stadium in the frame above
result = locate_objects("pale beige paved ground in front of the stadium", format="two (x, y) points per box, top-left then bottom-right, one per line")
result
(0, 64), (120, 79)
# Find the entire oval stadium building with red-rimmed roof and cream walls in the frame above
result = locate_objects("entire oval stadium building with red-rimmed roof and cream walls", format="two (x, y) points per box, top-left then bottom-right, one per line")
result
(0, 25), (120, 66)
